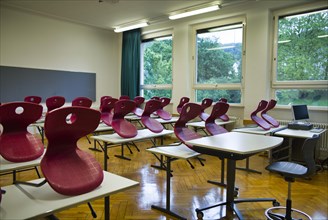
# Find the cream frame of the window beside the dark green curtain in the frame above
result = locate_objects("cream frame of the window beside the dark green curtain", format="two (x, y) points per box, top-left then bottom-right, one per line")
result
(140, 29), (174, 99)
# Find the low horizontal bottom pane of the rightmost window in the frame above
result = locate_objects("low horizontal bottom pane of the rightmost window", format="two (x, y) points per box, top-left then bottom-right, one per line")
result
(276, 89), (328, 106)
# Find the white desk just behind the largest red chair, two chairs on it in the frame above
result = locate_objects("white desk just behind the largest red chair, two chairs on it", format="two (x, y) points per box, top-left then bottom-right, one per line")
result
(91, 129), (173, 171)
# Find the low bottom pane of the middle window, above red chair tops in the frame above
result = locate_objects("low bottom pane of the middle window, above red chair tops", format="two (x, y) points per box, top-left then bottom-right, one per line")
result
(196, 89), (241, 103)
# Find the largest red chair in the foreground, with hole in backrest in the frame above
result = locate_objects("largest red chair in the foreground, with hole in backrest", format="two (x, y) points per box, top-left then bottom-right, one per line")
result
(40, 106), (103, 196)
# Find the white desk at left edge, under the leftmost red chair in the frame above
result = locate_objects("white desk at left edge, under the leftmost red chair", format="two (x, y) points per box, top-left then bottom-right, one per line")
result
(0, 151), (46, 182)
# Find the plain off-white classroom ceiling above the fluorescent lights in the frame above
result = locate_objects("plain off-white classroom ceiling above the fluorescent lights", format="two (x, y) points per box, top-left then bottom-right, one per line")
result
(0, 0), (249, 30)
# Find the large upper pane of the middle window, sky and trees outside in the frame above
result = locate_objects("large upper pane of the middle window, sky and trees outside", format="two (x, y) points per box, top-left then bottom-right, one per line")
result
(196, 24), (243, 84)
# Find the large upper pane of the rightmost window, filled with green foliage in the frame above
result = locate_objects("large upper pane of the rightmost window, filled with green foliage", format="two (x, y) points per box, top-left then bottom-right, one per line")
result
(276, 9), (328, 81)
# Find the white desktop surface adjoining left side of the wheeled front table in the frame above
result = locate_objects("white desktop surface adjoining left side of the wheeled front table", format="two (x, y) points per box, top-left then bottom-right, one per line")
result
(147, 144), (200, 160)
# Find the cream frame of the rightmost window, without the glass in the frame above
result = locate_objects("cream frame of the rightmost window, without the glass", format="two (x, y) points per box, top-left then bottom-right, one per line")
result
(271, 2), (328, 110)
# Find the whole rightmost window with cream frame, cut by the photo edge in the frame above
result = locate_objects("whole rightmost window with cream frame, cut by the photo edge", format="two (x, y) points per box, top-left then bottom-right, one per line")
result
(272, 8), (328, 106)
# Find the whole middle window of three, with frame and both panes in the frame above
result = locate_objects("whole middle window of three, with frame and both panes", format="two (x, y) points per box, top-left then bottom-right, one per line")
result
(194, 19), (244, 104)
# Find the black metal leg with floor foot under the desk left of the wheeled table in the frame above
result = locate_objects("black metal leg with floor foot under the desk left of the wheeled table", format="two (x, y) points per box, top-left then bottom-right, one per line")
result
(151, 157), (186, 220)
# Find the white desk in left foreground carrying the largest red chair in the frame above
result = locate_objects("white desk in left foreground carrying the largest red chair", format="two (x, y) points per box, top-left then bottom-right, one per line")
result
(0, 172), (139, 220)
